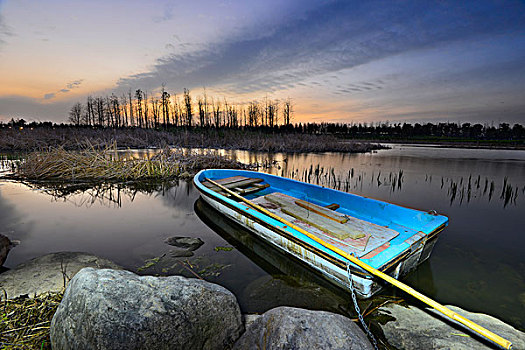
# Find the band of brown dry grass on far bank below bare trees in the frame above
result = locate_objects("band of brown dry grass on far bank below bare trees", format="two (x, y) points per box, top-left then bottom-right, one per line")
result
(0, 127), (383, 153)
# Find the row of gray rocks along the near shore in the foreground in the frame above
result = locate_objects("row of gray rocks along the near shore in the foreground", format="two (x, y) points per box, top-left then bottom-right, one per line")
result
(0, 252), (525, 349)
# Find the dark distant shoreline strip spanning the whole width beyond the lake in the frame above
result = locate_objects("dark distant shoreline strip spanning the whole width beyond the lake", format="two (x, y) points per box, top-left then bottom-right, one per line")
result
(0, 126), (525, 153)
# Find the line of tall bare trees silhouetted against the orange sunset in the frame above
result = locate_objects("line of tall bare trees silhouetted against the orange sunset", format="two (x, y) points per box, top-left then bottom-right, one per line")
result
(68, 86), (293, 129)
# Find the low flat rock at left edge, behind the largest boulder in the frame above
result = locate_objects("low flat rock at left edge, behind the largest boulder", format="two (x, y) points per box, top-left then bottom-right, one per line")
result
(0, 252), (121, 299)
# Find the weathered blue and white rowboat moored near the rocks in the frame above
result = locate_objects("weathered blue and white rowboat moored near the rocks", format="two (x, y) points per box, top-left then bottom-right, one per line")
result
(194, 169), (448, 298)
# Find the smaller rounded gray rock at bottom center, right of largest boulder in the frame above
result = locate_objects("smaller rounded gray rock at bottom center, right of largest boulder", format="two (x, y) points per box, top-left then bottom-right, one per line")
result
(234, 306), (373, 350)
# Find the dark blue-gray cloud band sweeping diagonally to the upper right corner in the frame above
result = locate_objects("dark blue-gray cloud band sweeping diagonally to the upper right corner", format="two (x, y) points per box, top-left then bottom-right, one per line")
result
(118, 1), (525, 93)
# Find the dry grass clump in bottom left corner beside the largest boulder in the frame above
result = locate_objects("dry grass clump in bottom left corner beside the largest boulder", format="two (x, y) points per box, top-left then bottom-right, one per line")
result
(0, 293), (63, 350)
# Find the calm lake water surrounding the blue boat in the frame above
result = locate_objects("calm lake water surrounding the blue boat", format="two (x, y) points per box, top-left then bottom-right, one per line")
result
(0, 145), (525, 330)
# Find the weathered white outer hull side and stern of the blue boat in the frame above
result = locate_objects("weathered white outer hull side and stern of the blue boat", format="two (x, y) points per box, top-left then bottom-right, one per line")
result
(195, 170), (445, 298)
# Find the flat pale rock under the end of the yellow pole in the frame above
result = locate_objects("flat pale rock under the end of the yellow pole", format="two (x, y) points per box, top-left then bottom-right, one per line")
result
(379, 304), (525, 350)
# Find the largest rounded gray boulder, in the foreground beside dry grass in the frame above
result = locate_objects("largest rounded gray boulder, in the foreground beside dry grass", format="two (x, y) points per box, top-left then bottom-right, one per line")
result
(51, 268), (244, 350)
